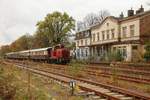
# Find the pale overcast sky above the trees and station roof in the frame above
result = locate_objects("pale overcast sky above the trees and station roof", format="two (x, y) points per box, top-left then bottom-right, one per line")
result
(0, 0), (150, 45)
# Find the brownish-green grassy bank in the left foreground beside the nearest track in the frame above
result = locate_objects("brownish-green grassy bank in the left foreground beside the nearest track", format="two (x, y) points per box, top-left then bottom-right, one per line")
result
(0, 61), (89, 100)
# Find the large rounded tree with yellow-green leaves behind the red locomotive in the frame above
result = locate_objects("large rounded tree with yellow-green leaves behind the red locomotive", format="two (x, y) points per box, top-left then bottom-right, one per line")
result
(37, 12), (75, 45)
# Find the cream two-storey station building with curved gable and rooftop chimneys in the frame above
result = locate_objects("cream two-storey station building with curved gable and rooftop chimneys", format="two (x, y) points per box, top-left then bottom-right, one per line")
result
(76, 6), (150, 61)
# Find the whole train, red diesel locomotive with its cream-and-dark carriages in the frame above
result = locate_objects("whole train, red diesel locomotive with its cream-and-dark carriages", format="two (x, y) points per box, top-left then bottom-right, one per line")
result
(6, 44), (71, 63)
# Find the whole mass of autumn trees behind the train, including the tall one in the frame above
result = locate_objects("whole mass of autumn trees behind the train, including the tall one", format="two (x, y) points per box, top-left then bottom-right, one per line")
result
(0, 11), (75, 55)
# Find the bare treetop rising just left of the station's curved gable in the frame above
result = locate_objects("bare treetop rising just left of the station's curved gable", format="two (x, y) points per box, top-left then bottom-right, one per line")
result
(97, 10), (110, 23)
